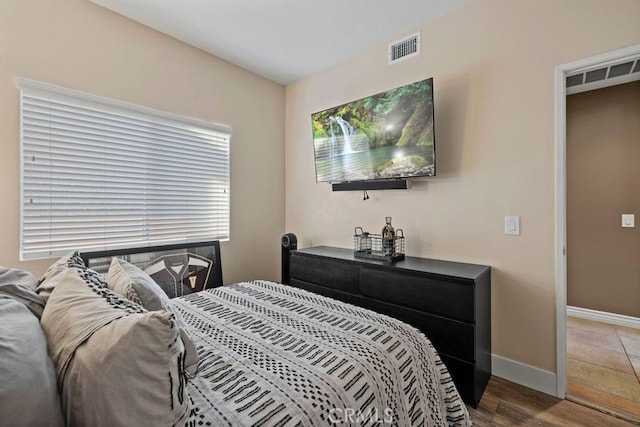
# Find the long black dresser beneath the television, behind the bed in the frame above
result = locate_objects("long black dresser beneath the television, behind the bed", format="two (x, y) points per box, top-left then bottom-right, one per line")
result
(289, 246), (491, 407)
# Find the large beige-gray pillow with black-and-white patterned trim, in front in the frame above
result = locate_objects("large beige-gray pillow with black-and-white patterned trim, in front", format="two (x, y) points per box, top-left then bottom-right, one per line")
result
(42, 268), (190, 427)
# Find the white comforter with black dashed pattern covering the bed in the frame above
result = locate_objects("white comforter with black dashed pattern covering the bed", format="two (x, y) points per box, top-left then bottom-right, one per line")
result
(173, 281), (471, 426)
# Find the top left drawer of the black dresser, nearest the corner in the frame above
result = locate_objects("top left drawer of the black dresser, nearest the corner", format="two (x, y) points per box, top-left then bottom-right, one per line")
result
(289, 252), (358, 293)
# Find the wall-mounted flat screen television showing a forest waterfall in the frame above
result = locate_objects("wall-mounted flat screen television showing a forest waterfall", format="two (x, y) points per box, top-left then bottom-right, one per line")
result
(311, 78), (436, 183)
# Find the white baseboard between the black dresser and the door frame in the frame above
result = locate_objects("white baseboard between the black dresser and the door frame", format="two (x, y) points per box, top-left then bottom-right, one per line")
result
(491, 354), (556, 396)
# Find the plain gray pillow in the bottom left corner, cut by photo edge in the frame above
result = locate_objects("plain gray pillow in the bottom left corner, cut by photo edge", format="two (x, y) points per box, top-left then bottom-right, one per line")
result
(0, 295), (64, 427)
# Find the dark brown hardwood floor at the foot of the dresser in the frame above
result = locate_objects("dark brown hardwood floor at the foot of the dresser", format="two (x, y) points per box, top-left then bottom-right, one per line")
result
(469, 377), (640, 427)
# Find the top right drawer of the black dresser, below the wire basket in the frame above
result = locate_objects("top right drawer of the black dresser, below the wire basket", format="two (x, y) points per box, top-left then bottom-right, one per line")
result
(360, 268), (474, 323)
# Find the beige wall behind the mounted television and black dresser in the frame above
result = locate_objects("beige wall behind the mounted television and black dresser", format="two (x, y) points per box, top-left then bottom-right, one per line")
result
(286, 0), (640, 372)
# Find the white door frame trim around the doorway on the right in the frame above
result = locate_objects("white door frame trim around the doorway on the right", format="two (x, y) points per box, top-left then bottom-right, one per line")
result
(555, 41), (640, 399)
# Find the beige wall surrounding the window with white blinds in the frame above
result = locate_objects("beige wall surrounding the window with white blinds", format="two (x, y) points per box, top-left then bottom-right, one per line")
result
(0, 0), (285, 283)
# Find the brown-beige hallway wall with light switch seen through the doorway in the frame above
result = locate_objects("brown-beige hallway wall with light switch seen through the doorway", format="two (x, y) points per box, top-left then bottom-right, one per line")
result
(567, 82), (640, 317)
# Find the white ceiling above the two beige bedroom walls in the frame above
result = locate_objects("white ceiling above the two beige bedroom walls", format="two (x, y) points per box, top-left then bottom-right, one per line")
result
(90, 0), (469, 85)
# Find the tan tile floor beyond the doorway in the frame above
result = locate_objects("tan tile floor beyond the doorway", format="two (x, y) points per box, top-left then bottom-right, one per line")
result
(567, 317), (640, 425)
